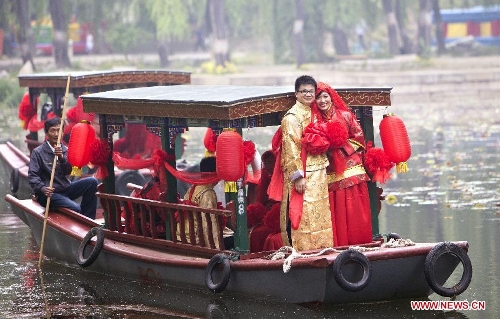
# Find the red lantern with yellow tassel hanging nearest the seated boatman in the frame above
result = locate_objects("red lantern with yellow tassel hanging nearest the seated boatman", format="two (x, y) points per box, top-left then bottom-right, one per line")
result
(68, 121), (95, 176)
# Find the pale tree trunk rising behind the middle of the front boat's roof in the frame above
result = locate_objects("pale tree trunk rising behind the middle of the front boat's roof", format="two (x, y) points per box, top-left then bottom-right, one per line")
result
(207, 0), (229, 66)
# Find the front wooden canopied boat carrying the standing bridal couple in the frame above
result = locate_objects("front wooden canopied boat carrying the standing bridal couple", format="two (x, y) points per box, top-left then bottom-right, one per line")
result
(6, 85), (472, 303)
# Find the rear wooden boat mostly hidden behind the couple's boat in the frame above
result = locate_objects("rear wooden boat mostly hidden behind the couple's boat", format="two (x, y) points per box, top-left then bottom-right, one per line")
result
(0, 70), (191, 197)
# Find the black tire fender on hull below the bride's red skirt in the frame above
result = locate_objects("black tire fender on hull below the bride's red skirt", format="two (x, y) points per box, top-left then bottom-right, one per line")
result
(333, 249), (372, 292)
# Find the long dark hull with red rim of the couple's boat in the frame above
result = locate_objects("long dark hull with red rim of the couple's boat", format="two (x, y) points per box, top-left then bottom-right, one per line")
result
(6, 195), (468, 303)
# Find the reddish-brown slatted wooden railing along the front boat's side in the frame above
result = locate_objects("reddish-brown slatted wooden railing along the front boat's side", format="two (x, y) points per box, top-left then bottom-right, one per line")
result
(96, 187), (234, 251)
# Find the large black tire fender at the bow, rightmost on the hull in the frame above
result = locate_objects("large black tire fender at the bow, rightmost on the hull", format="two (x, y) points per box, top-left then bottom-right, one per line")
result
(424, 242), (472, 297)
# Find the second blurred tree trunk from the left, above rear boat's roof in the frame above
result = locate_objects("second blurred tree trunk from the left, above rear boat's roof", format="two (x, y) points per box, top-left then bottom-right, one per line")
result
(49, 0), (73, 68)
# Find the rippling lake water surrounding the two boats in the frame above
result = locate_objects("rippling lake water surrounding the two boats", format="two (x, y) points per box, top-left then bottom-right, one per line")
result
(0, 101), (500, 318)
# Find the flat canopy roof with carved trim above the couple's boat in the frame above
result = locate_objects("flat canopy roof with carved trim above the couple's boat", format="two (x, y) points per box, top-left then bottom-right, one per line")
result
(82, 85), (391, 120)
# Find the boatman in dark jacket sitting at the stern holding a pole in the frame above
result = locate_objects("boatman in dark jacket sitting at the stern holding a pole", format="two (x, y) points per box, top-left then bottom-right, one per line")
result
(28, 117), (98, 219)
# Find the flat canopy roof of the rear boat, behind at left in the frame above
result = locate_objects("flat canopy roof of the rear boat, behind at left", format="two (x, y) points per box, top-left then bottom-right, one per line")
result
(18, 70), (191, 89)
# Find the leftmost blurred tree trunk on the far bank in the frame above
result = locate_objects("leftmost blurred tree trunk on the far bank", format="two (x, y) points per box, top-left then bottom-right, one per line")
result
(17, 0), (36, 71)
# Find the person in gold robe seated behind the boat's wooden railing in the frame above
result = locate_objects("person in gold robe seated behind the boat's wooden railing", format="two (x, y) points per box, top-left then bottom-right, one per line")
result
(178, 157), (234, 249)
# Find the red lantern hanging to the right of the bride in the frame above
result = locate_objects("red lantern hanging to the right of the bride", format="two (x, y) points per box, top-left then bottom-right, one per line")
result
(380, 113), (411, 173)
